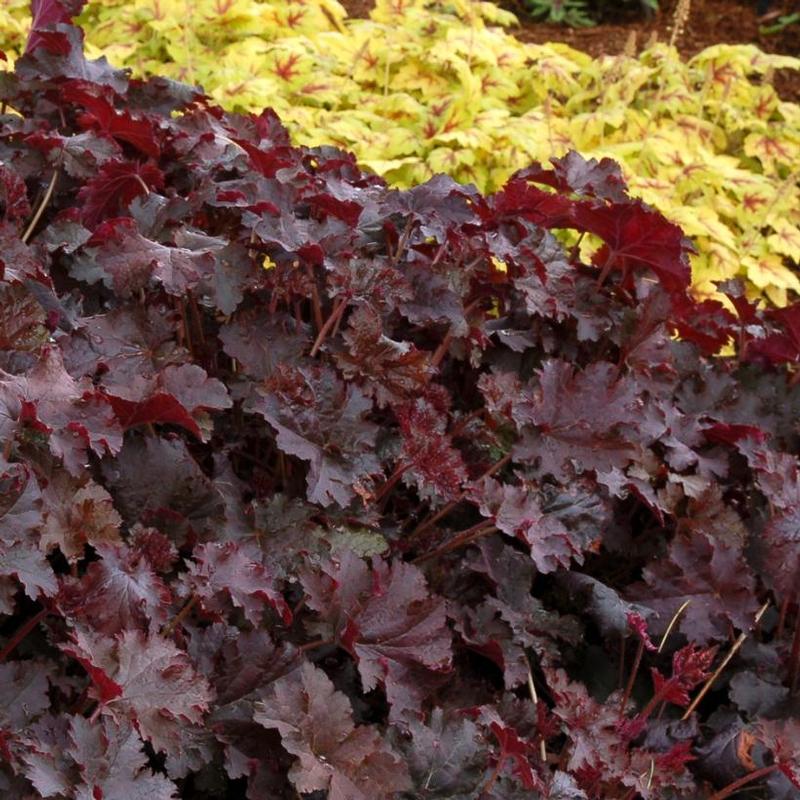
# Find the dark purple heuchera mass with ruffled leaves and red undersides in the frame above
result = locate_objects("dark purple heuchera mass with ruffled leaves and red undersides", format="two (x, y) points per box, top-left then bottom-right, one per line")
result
(0, 0), (800, 800)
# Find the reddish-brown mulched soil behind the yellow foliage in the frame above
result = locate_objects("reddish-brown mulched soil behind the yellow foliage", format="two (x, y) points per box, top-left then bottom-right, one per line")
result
(340, 0), (800, 103)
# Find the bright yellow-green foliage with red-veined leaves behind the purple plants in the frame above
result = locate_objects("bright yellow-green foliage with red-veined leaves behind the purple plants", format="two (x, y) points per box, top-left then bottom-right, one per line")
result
(0, 0), (800, 305)
